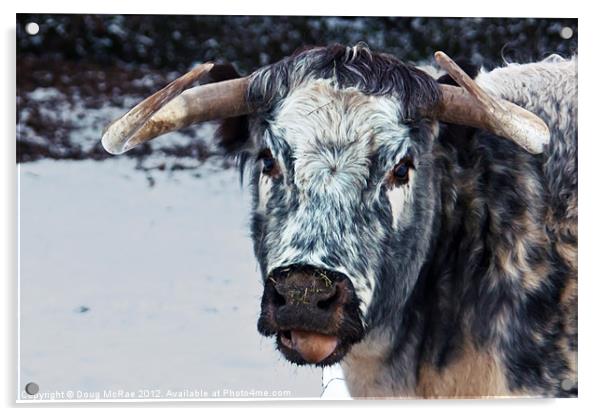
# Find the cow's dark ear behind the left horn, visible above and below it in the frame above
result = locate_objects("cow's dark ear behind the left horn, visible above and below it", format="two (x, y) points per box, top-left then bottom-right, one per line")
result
(211, 64), (249, 154)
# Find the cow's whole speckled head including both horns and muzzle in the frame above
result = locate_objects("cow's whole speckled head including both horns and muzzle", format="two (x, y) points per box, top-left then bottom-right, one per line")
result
(103, 45), (547, 365)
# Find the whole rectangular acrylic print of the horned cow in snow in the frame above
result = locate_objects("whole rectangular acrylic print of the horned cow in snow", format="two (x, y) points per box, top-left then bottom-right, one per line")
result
(16, 14), (578, 401)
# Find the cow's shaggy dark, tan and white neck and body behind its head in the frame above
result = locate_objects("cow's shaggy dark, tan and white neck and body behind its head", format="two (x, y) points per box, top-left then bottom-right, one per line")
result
(343, 60), (577, 397)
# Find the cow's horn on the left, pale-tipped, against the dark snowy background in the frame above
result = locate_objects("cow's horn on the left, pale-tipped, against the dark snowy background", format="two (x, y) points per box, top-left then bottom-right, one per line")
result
(102, 63), (252, 154)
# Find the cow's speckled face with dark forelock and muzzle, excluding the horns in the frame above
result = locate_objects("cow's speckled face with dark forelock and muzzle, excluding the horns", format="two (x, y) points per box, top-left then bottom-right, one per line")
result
(247, 47), (439, 364)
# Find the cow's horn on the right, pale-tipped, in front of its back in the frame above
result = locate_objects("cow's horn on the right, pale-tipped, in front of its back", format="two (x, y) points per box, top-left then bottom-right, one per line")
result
(429, 52), (550, 153)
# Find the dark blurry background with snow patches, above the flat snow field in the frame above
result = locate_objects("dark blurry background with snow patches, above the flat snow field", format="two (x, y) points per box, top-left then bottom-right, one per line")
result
(17, 14), (577, 163)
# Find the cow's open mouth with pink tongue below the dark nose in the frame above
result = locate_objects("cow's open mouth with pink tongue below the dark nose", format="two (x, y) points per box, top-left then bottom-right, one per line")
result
(276, 330), (347, 366)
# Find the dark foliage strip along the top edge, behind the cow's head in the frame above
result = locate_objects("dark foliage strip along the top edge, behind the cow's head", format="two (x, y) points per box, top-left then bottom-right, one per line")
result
(17, 14), (577, 73)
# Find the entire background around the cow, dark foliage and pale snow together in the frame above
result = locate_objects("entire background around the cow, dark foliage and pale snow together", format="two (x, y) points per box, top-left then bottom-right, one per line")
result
(17, 14), (577, 400)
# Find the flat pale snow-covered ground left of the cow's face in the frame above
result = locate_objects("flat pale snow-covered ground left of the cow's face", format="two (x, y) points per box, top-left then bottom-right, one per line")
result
(19, 158), (346, 400)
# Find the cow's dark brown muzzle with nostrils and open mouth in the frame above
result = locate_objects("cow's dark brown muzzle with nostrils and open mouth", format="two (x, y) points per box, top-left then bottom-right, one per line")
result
(258, 265), (363, 365)
